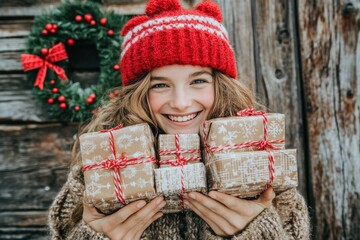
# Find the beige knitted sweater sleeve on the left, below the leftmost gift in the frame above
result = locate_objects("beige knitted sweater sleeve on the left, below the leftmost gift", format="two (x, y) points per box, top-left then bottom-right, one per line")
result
(49, 167), (108, 240)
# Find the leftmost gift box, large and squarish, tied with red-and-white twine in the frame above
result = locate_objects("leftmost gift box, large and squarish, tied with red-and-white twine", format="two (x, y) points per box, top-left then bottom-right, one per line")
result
(80, 123), (157, 213)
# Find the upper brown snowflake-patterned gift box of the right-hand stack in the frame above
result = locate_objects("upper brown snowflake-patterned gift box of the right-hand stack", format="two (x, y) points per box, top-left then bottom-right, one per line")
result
(200, 113), (285, 162)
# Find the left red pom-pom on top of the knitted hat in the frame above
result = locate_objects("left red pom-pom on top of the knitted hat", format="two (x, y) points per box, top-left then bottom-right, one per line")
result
(146, 0), (181, 17)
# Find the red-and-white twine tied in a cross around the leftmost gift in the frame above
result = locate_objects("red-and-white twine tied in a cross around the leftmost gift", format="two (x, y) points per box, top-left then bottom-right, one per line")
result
(82, 124), (156, 205)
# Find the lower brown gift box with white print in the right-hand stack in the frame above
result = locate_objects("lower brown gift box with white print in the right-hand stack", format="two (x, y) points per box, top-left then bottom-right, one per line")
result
(206, 149), (298, 198)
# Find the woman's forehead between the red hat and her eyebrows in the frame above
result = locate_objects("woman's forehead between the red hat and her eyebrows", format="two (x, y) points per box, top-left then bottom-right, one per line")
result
(151, 65), (211, 77)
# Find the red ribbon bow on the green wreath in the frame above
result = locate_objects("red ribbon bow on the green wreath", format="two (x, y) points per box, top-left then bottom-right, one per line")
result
(21, 43), (68, 90)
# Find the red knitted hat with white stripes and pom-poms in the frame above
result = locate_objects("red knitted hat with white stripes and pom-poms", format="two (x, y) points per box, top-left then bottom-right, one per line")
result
(121, 0), (236, 86)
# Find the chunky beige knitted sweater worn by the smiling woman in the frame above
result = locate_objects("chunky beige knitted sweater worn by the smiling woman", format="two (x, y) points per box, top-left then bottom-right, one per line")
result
(49, 164), (310, 240)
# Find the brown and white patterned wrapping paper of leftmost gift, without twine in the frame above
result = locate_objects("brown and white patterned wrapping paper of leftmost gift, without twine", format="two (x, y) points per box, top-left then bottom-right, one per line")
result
(80, 124), (156, 213)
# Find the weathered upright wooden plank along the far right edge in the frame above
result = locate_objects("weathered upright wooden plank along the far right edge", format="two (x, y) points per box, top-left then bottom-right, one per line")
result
(298, 0), (360, 239)
